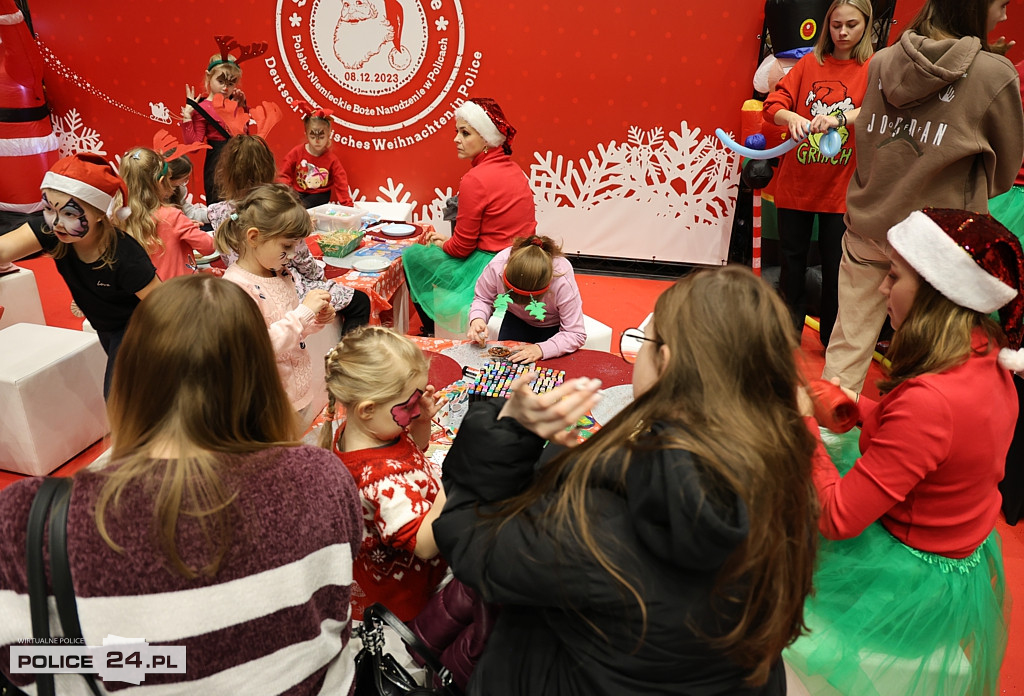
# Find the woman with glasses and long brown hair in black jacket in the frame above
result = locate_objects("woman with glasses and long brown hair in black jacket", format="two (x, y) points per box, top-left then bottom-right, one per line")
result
(434, 267), (817, 696)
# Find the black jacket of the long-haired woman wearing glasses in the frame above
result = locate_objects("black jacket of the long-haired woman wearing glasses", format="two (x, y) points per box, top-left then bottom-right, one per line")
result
(434, 401), (785, 696)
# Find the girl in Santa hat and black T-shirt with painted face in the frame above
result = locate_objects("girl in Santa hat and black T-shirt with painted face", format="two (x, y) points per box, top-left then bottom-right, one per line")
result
(0, 154), (160, 396)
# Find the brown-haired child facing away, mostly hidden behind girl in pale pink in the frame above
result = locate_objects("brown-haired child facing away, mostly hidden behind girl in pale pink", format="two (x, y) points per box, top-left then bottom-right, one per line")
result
(208, 135), (370, 332)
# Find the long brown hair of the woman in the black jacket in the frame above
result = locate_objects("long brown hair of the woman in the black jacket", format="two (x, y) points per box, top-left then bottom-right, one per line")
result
(495, 266), (818, 685)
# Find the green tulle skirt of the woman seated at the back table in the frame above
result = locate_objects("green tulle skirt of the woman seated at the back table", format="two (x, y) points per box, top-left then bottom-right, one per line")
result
(401, 244), (496, 334)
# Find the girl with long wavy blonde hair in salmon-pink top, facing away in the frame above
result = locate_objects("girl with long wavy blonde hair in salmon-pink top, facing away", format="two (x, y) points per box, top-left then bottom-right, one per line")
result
(121, 147), (214, 280)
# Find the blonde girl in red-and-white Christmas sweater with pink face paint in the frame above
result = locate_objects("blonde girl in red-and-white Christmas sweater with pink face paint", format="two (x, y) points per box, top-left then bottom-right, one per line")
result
(321, 327), (447, 621)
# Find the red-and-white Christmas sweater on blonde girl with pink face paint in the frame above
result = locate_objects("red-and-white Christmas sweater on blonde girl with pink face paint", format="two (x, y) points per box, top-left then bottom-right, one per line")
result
(334, 430), (447, 621)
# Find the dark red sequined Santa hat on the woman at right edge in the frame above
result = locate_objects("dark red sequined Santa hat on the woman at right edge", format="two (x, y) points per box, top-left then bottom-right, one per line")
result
(889, 208), (1024, 373)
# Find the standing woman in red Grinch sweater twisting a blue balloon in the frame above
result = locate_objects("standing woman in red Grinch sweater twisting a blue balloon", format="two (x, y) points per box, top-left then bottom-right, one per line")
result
(764, 0), (873, 346)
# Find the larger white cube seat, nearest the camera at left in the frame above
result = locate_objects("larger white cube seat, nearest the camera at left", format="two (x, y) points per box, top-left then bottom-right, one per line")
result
(0, 323), (110, 476)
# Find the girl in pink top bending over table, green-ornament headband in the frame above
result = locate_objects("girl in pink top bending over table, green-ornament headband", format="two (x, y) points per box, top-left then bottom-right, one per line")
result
(467, 234), (587, 362)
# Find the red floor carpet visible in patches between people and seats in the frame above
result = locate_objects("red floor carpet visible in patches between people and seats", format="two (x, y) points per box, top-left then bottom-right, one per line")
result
(0, 258), (1024, 696)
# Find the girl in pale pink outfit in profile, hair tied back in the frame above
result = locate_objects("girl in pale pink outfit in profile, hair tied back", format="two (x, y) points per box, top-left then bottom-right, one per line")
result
(216, 184), (334, 425)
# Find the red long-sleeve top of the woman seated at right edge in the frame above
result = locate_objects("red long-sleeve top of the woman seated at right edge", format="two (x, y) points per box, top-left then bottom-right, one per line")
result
(813, 332), (1017, 558)
